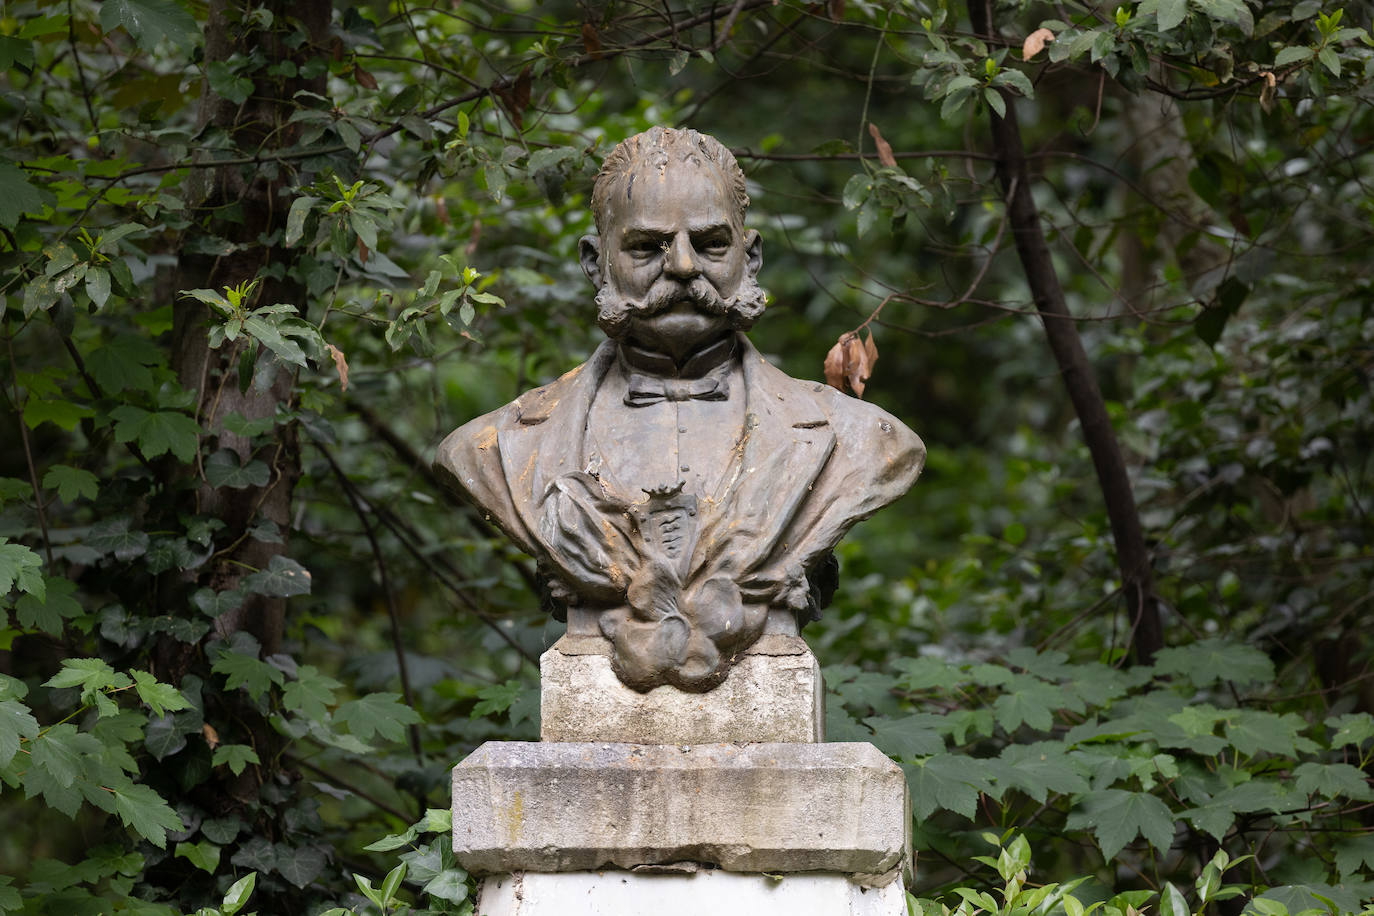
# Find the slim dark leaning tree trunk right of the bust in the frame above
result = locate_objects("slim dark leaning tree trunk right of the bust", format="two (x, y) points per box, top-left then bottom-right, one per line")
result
(969, 0), (1164, 663)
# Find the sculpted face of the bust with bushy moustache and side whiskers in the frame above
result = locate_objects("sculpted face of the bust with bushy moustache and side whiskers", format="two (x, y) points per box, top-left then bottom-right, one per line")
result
(581, 159), (767, 360)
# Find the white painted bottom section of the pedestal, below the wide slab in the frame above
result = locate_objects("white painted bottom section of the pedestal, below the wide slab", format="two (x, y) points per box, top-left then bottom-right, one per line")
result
(475, 871), (907, 916)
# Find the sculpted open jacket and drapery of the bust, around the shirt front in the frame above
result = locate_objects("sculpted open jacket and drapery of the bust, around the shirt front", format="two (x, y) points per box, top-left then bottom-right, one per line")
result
(434, 334), (925, 691)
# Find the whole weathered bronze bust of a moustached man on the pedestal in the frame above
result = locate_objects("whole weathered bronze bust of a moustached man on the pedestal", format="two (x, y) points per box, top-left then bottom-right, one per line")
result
(436, 128), (925, 691)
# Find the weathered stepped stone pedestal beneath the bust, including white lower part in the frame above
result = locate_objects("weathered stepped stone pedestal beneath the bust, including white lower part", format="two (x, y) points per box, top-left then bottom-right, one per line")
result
(453, 619), (911, 916)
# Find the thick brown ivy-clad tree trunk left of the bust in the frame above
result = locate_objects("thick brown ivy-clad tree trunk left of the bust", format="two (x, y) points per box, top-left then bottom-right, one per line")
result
(173, 0), (330, 655)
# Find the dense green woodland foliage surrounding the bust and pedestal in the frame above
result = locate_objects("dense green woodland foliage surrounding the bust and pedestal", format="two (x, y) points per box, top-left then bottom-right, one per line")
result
(0, 0), (1374, 916)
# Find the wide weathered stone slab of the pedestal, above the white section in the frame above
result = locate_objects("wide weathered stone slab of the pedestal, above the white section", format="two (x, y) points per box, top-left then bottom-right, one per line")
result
(453, 742), (911, 884)
